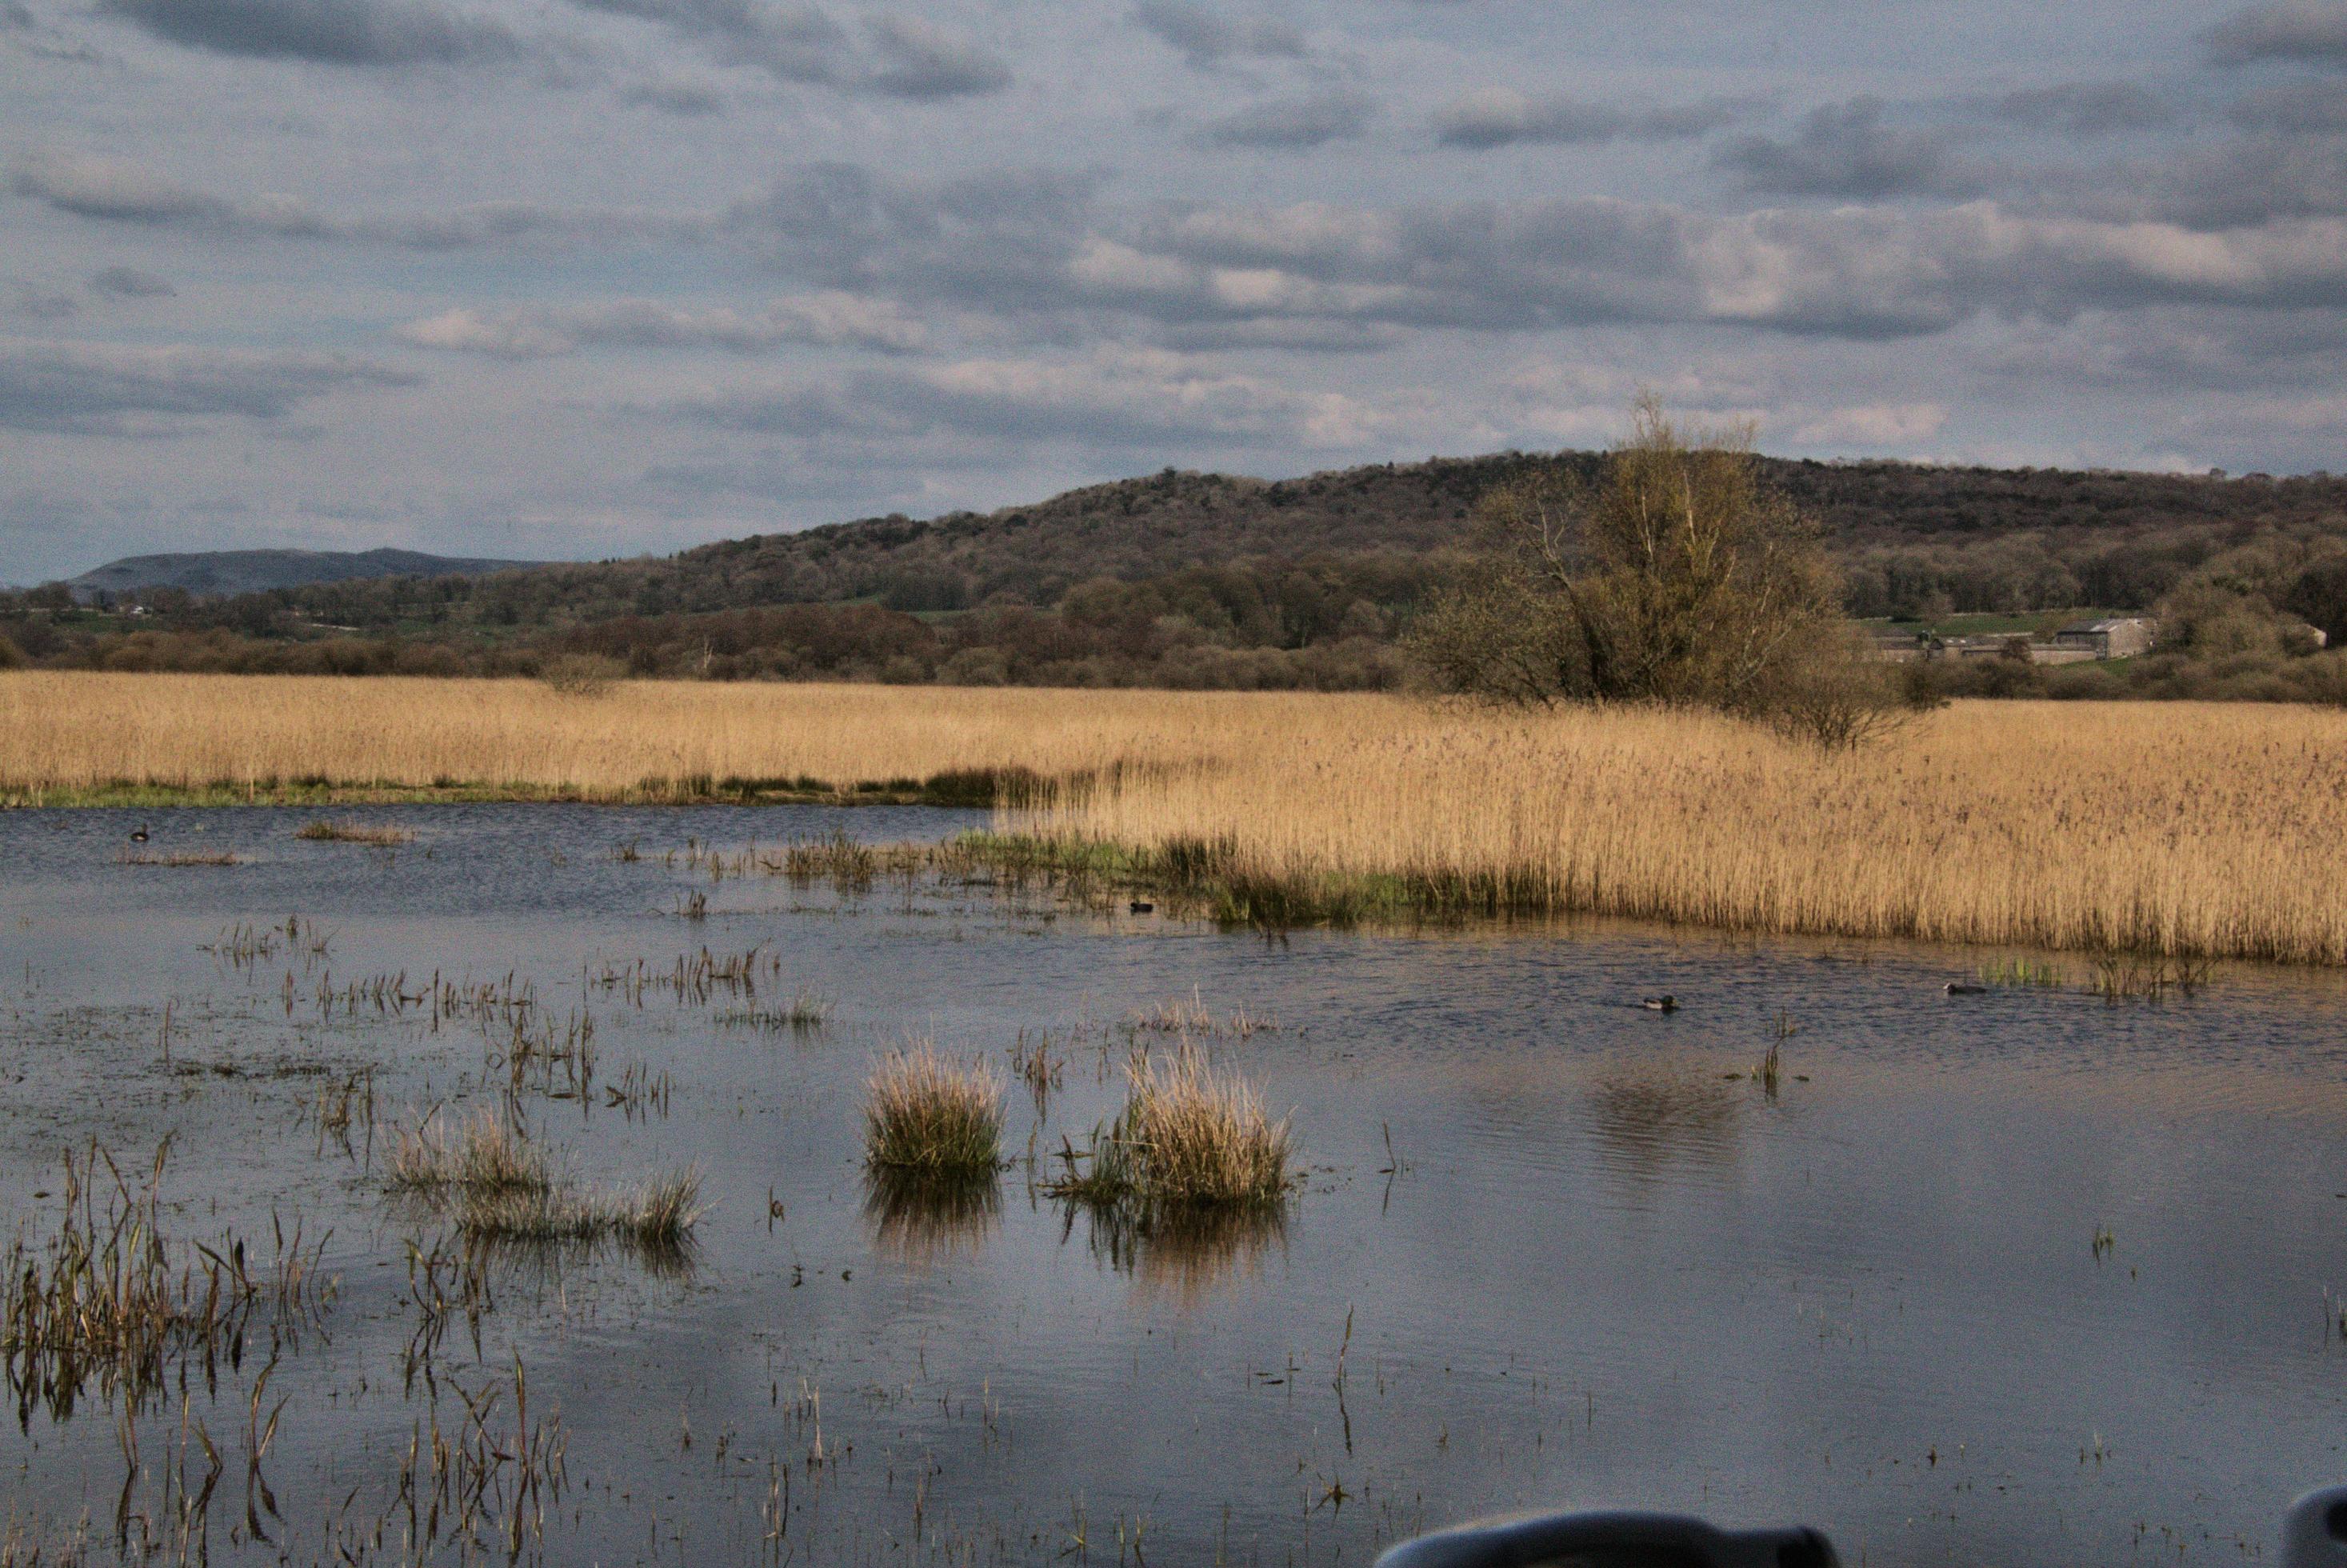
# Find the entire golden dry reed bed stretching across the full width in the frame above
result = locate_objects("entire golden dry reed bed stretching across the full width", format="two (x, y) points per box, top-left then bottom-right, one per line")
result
(0, 671), (2347, 965)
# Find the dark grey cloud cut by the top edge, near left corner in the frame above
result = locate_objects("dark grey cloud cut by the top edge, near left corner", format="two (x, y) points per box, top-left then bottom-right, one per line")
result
(101, 0), (521, 66)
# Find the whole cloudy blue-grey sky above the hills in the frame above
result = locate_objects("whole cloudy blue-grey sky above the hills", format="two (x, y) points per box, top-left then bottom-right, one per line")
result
(0, 0), (2347, 582)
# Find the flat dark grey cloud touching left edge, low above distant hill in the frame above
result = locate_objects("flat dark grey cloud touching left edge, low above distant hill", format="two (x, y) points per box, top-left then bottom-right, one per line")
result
(0, 345), (415, 434)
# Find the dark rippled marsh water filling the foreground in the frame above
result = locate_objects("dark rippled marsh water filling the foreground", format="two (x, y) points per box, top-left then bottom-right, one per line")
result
(0, 805), (2347, 1563)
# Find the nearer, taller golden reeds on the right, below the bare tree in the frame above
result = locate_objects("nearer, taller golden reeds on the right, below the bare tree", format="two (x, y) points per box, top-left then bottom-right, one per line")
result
(1005, 702), (2347, 965)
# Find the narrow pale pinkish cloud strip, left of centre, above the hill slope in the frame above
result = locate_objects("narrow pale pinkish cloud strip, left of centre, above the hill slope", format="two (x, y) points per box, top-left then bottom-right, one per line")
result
(399, 291), (927, 359)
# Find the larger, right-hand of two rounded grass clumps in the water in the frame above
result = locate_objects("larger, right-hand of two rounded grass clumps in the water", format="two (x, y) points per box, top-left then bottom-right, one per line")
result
(1049, 1045), (1291, 1221)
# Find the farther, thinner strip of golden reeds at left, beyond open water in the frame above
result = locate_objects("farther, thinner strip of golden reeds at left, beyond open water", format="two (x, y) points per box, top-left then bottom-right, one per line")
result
(0, 671), (1220, 807)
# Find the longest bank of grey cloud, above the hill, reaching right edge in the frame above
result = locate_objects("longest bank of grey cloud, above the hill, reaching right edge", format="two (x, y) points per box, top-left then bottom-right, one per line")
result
(1107, 199), (2347, 338)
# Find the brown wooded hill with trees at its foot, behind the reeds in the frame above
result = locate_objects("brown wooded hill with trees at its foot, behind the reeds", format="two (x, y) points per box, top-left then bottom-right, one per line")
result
(14, 453), (2347, 686)
